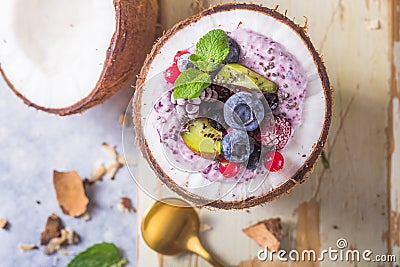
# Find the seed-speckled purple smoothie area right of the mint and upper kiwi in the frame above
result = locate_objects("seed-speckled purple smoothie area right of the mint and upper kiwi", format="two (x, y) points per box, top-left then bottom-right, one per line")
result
(229, 28), (308, 131)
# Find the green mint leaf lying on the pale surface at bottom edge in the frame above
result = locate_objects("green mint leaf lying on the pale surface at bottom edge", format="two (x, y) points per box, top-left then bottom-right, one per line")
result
(67, 243), (128, 267)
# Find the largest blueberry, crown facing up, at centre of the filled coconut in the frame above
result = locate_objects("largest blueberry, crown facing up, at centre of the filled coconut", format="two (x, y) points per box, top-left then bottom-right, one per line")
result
(224, 92), (265, 131)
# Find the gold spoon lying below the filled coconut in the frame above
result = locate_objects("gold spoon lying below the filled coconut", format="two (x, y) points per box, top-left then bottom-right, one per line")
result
(141, 198), (224, 267)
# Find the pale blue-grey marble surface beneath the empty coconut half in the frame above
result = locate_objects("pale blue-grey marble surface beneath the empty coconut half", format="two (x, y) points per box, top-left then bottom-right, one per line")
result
(0, 78), (139, 267)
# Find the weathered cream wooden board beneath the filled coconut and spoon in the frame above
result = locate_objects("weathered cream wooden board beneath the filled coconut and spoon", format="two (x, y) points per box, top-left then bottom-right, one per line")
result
(138, 0), (394, 267)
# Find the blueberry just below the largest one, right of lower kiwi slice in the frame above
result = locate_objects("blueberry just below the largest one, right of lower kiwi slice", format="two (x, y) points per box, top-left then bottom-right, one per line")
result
(221, 130), (254, 162)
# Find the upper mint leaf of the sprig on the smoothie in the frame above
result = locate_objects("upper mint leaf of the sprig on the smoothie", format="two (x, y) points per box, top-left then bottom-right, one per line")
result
(190, 30), (229, 72)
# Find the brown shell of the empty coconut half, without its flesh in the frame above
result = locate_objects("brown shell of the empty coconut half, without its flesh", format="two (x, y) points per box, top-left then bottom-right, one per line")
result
(0, 0), (158, 116)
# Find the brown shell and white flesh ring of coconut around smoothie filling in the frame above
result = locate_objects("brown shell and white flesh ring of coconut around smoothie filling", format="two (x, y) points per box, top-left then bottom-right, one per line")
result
(133, 3), (332, 209)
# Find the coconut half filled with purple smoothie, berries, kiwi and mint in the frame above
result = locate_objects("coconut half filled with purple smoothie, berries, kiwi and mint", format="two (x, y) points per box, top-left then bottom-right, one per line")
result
(133, 3), (332, 209)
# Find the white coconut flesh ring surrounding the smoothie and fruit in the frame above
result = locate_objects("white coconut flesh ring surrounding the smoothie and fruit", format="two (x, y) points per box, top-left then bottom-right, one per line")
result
(141, 9), (327, 202)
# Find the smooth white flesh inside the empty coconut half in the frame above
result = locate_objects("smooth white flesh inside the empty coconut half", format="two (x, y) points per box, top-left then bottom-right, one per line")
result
(0, 0), (116, 109)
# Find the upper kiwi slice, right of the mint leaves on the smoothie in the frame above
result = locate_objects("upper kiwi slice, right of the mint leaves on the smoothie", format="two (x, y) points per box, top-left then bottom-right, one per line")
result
(214, 63), (277, 93)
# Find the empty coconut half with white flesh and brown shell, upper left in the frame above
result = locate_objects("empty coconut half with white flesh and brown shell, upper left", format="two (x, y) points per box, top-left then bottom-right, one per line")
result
(0, 0), (158, 115)
